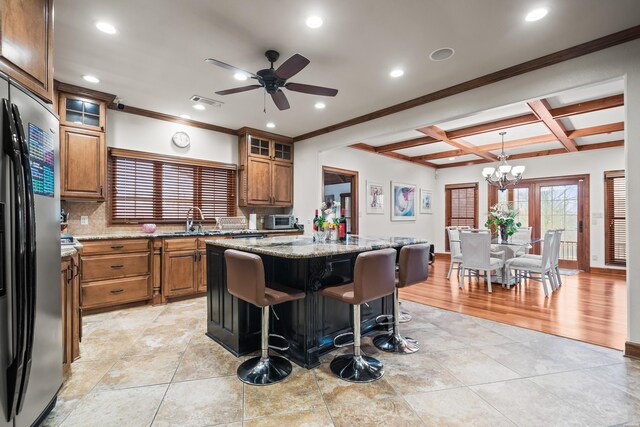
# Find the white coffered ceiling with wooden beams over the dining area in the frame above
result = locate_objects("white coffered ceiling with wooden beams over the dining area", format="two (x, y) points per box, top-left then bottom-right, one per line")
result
(352, 79), (625, 168)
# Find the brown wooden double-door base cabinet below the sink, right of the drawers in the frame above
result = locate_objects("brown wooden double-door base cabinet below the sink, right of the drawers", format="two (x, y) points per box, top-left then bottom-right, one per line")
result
(162, 237), (207, 298)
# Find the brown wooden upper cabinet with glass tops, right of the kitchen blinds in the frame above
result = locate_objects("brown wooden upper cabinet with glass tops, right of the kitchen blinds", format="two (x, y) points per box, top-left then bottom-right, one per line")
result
(238, 128), (293, 207)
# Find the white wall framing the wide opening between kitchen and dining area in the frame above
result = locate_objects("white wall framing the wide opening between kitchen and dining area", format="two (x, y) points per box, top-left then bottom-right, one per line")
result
(294, 40), (640, 343)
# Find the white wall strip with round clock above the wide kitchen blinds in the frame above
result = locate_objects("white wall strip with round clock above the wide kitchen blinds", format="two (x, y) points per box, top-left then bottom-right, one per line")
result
(107, 110), (238, 164)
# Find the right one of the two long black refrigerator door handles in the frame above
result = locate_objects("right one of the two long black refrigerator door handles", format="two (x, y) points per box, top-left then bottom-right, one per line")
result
(11, 104), (37, 414)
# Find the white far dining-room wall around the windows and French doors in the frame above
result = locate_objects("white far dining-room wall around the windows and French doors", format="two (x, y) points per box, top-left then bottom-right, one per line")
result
(434, 147), (624, 267)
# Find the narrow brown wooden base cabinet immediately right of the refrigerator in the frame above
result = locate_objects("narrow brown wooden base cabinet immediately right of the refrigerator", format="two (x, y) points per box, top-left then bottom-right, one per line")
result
(60, 255), (82, 372)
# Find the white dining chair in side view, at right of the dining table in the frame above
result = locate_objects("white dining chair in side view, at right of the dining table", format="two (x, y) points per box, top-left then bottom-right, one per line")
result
(506, 230), (556, 297)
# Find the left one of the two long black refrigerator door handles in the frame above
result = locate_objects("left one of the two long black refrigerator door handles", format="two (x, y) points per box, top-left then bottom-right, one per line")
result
(2, 99), (27, 419)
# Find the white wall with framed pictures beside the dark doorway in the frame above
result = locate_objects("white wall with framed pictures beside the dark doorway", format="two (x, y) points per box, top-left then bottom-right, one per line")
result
(312, 146), (435, 239)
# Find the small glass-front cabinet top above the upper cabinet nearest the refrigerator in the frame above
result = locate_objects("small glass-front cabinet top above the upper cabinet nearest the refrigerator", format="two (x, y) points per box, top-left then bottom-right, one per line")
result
(58, 93), (107, 132)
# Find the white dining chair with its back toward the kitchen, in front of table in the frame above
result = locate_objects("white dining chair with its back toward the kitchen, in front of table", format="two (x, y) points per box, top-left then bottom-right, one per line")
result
(459, 230), (505, 293)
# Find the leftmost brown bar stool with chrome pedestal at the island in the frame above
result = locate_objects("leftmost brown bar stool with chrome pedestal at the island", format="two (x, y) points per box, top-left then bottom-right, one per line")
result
(224, 249), (305, 385)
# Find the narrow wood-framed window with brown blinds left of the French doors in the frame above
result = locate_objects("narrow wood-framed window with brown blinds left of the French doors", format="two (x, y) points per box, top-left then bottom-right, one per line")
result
(444, 183), (478, 251)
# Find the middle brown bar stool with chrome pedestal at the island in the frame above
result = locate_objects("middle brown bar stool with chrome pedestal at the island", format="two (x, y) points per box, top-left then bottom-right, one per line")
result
(320, 249), (397, 383)
